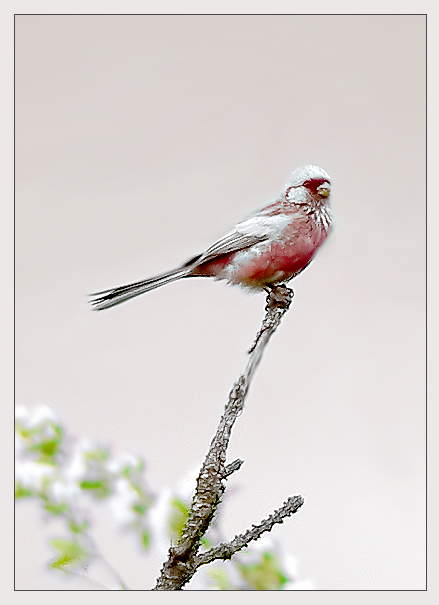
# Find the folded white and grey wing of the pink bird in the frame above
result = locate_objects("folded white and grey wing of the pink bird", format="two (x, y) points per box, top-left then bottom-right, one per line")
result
(197, 214), (289, 264)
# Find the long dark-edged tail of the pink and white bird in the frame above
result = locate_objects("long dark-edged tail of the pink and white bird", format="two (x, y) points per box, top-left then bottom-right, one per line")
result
(90, 267), (189, 311)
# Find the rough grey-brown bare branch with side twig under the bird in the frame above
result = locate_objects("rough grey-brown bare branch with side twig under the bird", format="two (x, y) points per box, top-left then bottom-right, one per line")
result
(153, 286), (303, 590)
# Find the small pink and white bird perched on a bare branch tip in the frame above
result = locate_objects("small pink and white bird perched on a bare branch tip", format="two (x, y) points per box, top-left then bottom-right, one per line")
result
(90, 165), (333, 311)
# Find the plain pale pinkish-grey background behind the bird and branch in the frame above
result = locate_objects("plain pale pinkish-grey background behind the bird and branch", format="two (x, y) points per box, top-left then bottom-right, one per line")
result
(16, 15), (425, 590)
